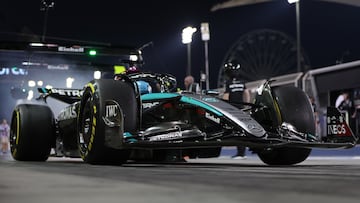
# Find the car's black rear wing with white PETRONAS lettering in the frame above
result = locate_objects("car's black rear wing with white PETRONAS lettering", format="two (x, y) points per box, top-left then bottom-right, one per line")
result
(37, 88), (83, 104)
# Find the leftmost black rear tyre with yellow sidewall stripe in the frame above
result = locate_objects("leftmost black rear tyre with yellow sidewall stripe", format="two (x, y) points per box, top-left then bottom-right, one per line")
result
(10, 104), (55, 161)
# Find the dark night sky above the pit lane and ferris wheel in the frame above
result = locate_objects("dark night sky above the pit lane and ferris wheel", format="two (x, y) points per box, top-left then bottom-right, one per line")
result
(0, 0), (360, 88)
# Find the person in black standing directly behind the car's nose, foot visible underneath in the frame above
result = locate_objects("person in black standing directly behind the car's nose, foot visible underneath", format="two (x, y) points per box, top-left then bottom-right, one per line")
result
(223, 62), (250, 159)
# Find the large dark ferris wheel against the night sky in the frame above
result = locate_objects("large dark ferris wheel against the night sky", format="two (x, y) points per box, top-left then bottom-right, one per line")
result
(218, 29), (310, 88)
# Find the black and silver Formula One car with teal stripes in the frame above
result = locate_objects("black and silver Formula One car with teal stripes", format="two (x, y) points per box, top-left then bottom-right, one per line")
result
(10, 73), (358, 165)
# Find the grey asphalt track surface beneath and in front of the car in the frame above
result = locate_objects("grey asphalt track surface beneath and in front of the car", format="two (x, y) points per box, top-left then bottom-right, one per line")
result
(0, 151), (360, 203)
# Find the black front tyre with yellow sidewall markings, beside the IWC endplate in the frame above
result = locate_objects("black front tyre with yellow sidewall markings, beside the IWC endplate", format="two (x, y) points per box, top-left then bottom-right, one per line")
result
(78, 80), (139, 165)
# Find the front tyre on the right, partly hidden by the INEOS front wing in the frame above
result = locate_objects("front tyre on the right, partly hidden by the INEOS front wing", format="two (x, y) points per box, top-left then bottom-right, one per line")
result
(258, 86), (315, 165)
